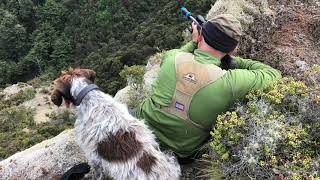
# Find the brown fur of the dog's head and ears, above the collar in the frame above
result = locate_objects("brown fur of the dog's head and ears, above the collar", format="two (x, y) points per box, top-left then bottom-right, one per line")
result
(51, 68), (96, 107)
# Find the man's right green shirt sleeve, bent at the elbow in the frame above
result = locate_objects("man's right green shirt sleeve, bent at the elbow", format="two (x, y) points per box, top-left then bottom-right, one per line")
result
(229, 57), (282, 98)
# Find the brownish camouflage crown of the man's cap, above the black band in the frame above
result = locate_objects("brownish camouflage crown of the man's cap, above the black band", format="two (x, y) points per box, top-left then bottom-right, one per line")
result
(208, 14), (242, 41)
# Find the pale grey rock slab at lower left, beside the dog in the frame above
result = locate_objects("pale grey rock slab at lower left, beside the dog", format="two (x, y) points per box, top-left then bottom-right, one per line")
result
(0, 130), (86, 179)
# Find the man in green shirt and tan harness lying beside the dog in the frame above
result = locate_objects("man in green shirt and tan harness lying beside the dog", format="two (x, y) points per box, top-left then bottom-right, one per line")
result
(136, 14), (281, 158)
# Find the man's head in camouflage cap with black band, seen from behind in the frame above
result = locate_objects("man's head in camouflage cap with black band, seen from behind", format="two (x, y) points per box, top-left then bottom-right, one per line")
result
(198, 14), (242, 54)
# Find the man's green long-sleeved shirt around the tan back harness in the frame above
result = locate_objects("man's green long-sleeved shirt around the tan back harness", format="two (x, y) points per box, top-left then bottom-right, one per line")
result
(136, 42), (281, 157)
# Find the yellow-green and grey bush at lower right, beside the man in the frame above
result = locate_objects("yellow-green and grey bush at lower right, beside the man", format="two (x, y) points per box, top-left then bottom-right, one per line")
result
(210, 75), (320, 179)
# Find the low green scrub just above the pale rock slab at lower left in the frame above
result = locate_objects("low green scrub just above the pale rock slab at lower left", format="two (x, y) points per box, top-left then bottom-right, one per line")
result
(0, 107), (75, 159)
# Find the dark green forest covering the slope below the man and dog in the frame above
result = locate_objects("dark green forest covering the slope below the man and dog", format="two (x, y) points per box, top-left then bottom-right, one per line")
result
(0, 0), (212, 94)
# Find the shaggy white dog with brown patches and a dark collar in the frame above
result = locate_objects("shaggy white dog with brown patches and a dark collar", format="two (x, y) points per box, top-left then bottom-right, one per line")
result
(51, 68), (181, 180)
